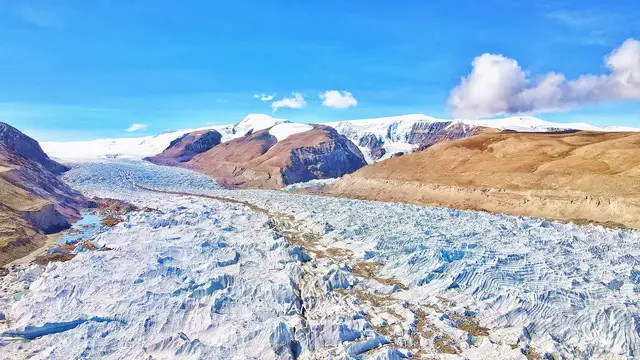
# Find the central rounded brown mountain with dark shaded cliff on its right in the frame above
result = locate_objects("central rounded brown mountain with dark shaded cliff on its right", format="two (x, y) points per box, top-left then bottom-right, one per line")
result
(186, 125), (366, 189)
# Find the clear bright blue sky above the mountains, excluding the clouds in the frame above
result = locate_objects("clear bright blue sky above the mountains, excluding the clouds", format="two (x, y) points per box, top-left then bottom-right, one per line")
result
(0, 0), (640, 140)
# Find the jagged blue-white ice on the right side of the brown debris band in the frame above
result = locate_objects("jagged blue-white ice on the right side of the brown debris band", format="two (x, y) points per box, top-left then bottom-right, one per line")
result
(219, 190), (640, 357)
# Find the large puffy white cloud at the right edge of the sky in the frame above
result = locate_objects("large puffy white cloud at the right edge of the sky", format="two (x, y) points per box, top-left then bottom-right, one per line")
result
(449, 39), (640, 117)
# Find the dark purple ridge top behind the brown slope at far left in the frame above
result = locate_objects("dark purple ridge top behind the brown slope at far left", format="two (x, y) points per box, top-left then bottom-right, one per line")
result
(0, 122), (69, 174)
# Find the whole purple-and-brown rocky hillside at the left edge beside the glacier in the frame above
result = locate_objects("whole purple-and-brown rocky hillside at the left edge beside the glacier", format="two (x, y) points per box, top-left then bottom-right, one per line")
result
(0, 123), (86, 266)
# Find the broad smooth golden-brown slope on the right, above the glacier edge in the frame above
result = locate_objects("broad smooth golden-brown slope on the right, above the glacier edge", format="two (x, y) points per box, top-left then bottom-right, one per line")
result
(327, 132), (640, 228)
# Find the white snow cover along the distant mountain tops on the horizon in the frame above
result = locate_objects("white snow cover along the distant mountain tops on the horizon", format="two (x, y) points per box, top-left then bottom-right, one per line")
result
(41, 114), (640, 162)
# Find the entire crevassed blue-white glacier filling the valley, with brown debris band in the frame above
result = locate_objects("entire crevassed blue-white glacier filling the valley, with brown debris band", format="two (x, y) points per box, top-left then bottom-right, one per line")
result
(0, 161), (640, 359)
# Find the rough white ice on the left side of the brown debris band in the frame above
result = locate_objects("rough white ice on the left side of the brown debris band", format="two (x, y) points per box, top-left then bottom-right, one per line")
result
(0, 174), (310, 359)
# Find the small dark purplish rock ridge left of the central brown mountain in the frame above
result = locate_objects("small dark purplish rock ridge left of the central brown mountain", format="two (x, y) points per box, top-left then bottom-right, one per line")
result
(144, 130), (222, 165)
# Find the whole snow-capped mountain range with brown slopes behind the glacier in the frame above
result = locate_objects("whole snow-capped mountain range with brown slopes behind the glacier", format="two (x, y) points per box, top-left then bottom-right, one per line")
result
(5, 114), (640, 232)
